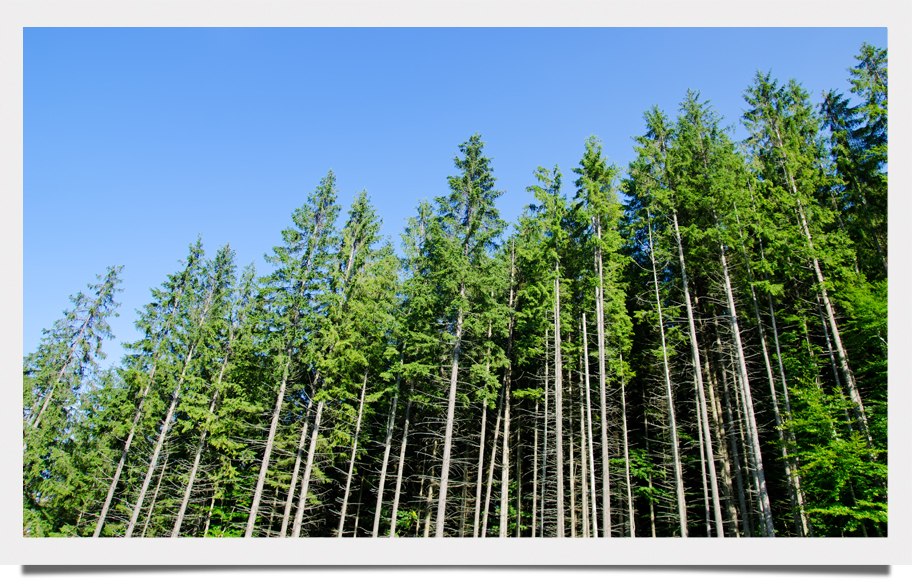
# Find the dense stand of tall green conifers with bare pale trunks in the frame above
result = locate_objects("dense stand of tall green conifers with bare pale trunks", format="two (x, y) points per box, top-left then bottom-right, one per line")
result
(22, 43), (888, 537)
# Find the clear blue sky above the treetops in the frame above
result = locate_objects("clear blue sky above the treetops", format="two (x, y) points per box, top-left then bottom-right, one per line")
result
(23, 28), (887, 363)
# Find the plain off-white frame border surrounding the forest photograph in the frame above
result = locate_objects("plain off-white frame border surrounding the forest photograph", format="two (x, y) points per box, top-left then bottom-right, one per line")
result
(0, 0), (912, 565)
